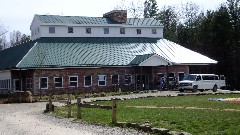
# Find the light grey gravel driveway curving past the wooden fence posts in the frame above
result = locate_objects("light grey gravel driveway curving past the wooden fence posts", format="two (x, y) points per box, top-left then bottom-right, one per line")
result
(0, 91), (239, 135)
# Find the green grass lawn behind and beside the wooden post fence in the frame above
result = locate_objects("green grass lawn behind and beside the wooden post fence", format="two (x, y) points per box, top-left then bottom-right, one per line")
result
(54, 94), (240, 135)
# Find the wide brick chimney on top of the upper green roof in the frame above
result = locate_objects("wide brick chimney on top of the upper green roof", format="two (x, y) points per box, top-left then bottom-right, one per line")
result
(103, 10), (127, 23)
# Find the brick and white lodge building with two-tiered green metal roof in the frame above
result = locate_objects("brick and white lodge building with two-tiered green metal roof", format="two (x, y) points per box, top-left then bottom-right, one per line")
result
(0, 10), (217, 95)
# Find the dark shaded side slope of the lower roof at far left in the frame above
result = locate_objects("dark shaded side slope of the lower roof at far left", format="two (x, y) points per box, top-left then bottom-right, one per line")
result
(0, 41), (35, 69)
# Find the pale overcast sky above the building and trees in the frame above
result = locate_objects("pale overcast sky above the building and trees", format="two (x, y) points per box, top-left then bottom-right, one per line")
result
(0, 0), (226, 35)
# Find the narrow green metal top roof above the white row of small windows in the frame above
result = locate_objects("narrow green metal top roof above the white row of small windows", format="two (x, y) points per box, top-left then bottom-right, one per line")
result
(35, 15), (161, 25)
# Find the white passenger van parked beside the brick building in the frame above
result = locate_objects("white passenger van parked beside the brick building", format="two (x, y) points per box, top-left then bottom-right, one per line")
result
(178, 74), (225, 92)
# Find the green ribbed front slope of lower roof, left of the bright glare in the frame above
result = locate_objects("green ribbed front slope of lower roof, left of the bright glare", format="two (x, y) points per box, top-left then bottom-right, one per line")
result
(18, 37), (161, 68)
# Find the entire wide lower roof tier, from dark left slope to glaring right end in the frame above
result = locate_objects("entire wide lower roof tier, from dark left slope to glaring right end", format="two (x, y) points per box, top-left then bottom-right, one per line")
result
(0, 37), (217, 69)
